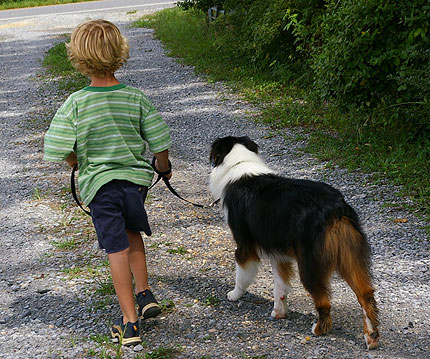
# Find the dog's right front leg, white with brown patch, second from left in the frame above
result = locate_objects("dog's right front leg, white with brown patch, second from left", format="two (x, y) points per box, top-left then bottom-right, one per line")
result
(270, 258), (294, 319)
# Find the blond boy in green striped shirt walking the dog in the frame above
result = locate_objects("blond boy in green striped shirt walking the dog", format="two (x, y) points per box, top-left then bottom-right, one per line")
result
(44, 20), (172, 345)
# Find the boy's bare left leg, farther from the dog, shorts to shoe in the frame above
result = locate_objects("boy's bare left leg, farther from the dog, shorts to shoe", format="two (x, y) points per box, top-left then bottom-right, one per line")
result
(108, 248), (137, 324)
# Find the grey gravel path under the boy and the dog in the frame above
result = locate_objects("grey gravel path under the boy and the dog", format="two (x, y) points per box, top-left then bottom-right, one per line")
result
(0, 6), (430, 359)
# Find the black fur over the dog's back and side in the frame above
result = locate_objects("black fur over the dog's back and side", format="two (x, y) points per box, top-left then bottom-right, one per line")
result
(224, 174), (362, 253)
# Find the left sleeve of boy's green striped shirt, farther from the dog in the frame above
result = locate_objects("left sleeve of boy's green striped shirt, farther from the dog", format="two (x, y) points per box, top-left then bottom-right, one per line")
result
(43, 99), (76, 162)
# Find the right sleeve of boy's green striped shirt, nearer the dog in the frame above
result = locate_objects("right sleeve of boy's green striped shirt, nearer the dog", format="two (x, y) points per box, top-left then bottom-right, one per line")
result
(141, 105), (172, 153)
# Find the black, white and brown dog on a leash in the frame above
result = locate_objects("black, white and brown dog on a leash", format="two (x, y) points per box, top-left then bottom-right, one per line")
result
(209, 136), (379, 349)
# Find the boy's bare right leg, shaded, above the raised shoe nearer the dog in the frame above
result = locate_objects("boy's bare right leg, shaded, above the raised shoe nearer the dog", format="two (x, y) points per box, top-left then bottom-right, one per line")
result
(127, 230), (149, 294)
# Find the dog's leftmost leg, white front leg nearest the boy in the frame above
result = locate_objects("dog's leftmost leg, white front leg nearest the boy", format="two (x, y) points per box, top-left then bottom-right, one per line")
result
(227, 247), (260, 301)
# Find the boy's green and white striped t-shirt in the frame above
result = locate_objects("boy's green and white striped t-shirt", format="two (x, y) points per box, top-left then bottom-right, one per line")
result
(43, 84), (171, 205)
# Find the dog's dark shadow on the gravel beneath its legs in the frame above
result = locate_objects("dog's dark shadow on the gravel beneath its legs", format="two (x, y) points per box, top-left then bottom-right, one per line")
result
(152, 276), (376, 344)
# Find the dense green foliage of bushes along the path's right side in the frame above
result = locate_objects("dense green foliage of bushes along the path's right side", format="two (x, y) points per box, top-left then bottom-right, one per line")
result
(181, 0), (430, 131)
